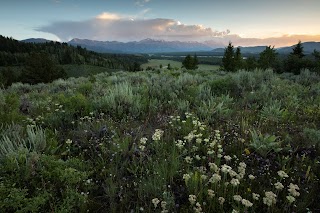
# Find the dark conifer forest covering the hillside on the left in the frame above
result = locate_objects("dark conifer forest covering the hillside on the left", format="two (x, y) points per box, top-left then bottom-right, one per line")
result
(0, 35), (147, 86)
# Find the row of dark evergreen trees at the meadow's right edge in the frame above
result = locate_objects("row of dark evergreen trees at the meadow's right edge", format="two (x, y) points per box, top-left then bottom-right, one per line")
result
(220, 41), (320, 75)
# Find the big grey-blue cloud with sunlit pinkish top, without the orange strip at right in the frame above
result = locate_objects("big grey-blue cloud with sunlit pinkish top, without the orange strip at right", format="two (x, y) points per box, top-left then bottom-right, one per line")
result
(36, 13), (229, 41)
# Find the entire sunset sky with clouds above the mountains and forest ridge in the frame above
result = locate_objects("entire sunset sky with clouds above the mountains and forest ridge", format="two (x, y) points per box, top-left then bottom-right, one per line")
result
(0, 0), (320, 47)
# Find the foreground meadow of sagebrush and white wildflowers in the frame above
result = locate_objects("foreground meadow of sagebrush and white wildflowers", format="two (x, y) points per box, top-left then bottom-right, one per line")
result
(0, 68), (320, 213)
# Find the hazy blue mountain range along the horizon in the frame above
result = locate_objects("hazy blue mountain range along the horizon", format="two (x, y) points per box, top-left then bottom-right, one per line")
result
(22, 38), (320, 54)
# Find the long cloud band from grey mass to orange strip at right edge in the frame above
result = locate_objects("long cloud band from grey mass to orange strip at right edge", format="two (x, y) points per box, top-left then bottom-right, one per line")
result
(36, 13), (320, 47)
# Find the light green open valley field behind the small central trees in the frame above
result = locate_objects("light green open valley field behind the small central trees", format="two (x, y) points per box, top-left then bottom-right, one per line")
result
(141, 59), (219, 71)
